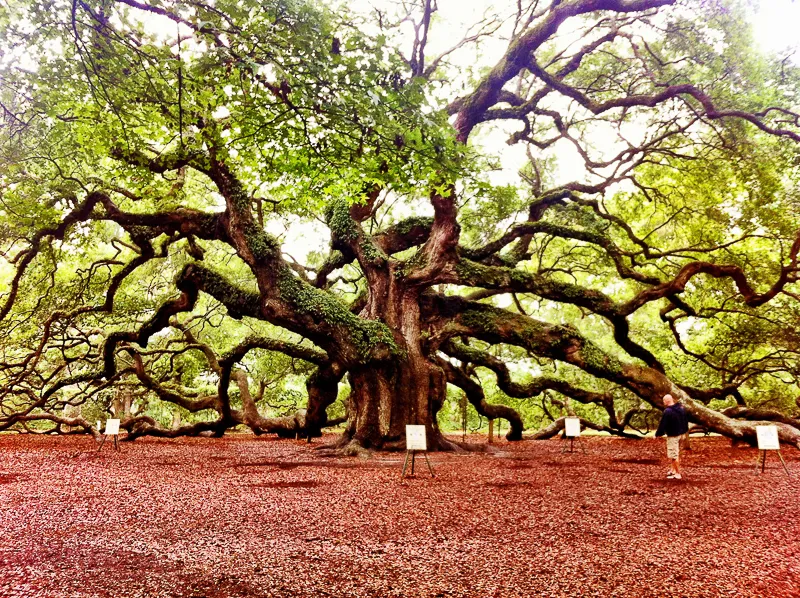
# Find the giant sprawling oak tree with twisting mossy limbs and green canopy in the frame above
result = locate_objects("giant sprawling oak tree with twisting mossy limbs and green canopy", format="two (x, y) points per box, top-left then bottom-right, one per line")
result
(0, 0), (800, 452)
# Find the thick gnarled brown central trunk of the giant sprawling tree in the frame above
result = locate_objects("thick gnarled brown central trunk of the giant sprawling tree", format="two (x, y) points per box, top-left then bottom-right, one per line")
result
(312, 191), (472, 451)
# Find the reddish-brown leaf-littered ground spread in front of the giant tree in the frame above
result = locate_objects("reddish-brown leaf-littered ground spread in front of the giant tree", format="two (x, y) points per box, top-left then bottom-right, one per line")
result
(0, 436), (800, 598)
